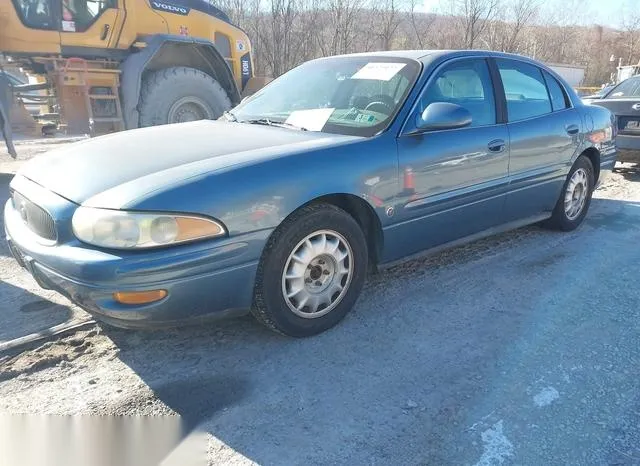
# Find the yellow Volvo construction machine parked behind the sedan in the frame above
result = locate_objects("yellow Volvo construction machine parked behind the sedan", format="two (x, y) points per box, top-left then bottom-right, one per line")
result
(0, 0), (265, 157)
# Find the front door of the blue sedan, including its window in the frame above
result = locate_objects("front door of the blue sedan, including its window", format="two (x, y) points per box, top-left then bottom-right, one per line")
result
(388, 58), (509, 260)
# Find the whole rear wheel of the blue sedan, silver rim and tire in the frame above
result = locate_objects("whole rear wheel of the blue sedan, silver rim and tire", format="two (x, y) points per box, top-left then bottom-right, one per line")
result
(543, 155), (595, 231)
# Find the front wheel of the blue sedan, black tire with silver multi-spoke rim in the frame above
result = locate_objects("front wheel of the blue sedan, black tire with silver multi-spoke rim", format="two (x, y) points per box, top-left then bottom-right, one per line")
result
(251, 204), (368, 337)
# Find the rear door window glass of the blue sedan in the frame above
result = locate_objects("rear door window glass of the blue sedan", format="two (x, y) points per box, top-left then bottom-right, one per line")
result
(496, 59), (551, 121)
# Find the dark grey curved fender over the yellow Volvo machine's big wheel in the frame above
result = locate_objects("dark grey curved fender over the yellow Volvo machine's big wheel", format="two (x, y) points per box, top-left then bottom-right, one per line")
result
(120, 34), (240, 129)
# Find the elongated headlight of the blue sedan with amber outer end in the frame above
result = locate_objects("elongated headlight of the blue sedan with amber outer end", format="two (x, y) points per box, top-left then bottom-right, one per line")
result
(72, 207), (225, 249)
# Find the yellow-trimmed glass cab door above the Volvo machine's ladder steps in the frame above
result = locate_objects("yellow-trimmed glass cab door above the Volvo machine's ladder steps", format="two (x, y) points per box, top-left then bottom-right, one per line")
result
(60, 0), (123, 52)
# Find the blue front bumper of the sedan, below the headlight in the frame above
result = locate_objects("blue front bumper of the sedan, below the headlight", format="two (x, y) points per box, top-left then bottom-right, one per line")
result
(4, 201), (271, 328)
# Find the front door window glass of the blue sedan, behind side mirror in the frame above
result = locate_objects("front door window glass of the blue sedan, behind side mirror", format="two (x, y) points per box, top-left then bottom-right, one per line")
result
(420, 59), (496, 126)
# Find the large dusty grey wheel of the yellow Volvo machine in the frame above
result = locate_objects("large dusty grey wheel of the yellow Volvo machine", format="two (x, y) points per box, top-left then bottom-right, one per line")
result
(139, 66), (231, 127)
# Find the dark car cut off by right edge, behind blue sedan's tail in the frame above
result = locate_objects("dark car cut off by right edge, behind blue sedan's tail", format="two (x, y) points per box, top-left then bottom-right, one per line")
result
(590, 76), (640, 163)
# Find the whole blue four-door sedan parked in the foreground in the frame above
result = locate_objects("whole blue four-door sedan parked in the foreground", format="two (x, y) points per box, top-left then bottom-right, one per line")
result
(4, 51), (616, 337)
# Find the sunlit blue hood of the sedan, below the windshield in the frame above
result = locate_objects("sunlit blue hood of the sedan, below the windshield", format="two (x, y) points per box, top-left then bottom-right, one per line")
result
(18, 120), (357, 204)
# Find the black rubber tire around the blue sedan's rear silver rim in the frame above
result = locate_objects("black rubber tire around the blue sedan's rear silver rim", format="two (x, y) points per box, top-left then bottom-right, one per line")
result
(543, 155), (595, 231)
